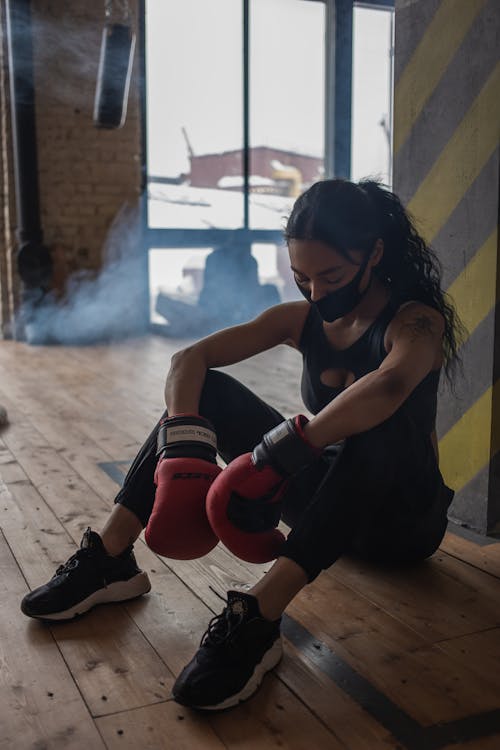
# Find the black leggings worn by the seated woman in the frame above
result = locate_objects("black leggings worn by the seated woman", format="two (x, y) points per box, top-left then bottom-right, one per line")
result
(115, 370), (453, 581)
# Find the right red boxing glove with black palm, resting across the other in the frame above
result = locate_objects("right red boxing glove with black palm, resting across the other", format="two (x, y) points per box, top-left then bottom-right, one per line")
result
(207, 415), (321, 563)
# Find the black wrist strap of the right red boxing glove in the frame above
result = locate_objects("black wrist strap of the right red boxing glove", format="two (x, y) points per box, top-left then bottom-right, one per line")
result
(252, 414), (321, 477)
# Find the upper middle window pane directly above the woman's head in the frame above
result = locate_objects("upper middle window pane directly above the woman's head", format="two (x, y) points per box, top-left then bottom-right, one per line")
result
(250, 0), (325, 229)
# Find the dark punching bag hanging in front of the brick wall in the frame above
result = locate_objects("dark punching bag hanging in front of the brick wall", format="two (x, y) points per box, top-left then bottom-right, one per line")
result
(94, 23), (135, 128)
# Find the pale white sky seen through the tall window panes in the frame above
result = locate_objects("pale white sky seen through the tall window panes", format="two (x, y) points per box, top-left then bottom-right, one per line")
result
(146, 0), (389, 184)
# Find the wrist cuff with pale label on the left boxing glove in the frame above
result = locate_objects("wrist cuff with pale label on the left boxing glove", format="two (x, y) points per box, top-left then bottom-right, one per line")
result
(156, 414), (217, 462)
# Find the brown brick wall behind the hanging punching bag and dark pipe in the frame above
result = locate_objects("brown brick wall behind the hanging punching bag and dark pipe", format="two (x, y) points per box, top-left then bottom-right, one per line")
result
(0, 0), (145, 334)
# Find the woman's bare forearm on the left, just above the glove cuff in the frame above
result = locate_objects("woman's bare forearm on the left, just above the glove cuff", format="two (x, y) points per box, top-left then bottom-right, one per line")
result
(165, 347), (207, 416)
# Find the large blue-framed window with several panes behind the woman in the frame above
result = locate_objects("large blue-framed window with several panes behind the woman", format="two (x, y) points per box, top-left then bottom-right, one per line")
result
(145, 0), (391, 336)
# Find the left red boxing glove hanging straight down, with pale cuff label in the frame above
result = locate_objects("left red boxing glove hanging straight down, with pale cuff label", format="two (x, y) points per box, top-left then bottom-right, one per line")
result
(145, 414), (221, 560)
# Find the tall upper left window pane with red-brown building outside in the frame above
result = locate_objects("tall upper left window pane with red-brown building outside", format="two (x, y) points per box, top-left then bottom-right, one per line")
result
(146, 0), (243, 229)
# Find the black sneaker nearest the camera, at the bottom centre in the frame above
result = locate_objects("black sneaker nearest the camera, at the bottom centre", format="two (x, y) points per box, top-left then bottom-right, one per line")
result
(172, 591), (283, 711)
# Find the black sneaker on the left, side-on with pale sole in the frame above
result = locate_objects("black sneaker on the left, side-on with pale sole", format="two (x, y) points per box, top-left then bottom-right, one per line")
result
(21, 527), (151, 620)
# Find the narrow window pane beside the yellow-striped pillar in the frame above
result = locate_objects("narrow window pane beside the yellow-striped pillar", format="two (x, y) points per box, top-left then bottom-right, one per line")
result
(351, 6), (394, 185)
